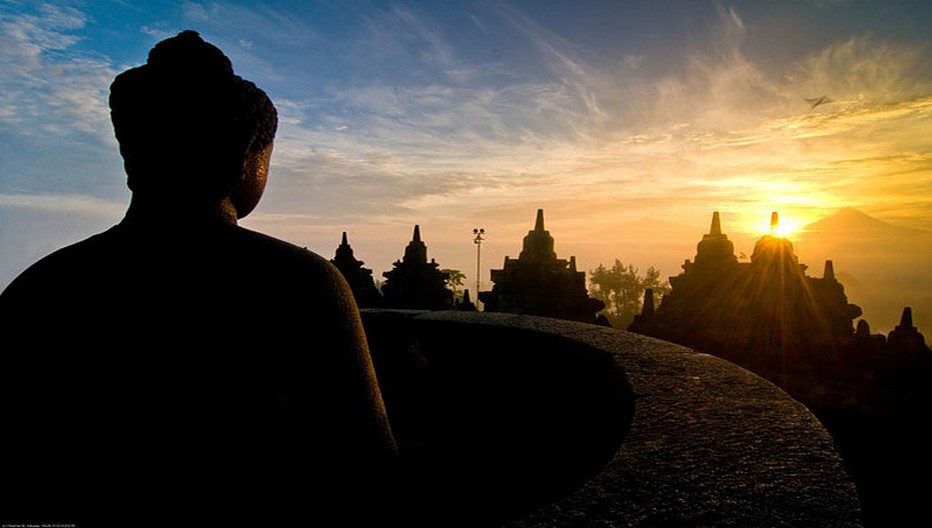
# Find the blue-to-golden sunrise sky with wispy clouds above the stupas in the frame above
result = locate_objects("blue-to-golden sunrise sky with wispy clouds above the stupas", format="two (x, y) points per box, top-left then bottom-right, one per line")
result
(0, 0), (932, 287)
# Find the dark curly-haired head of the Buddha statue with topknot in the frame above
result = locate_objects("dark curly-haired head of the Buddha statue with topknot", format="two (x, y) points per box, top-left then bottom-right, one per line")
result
(110, 31), (278, 218)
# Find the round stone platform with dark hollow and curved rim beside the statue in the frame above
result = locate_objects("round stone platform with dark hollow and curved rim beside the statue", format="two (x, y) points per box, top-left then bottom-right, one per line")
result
(363, 310), (861, 528)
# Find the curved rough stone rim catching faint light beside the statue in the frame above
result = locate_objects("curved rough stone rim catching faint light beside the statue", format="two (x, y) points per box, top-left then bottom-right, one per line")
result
(366, 311), (861, 528)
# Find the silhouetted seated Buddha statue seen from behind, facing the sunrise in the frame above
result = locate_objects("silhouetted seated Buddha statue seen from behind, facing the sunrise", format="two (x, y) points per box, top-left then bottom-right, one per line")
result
(0, 31), (396, 526)
